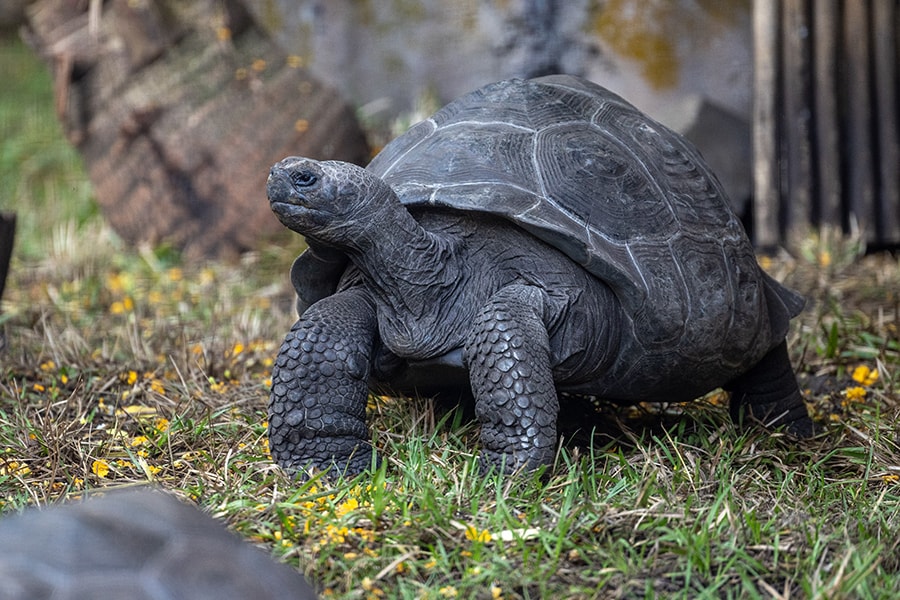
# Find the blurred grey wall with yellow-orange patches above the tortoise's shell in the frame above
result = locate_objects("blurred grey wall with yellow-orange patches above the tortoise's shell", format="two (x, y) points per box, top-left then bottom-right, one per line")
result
(247, 0), (752, 124)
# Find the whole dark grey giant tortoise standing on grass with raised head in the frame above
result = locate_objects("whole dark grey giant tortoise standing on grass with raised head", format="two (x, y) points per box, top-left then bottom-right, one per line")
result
(267, 76), (812, 473)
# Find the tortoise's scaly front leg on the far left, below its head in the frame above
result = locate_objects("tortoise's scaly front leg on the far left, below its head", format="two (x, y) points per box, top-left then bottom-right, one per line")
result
(269, 289), (377, 475)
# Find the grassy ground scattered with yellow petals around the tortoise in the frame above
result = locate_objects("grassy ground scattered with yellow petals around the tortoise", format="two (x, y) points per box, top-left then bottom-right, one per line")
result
(0, 36), (900, 598)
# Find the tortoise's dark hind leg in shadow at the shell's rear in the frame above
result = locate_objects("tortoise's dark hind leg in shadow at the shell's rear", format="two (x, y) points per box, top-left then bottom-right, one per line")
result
(725, 342), (813, 438)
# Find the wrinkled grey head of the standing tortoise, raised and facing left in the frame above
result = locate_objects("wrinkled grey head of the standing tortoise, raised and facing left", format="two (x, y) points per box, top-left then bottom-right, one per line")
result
(266, 156), (399, 245)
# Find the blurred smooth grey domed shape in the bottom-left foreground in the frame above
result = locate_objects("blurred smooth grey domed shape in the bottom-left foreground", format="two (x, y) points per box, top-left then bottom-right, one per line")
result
(0, 489), (316, 600)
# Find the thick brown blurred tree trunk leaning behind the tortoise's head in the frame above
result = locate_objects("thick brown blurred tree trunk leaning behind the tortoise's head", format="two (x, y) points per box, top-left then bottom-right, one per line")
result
(28, 0), (368, 258)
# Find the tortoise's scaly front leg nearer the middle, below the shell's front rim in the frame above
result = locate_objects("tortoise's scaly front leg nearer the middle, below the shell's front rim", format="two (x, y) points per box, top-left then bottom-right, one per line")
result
(465, 285), (559, 472)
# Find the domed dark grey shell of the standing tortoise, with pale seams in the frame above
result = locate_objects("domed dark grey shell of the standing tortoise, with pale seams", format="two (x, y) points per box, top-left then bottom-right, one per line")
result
(367, 75), (802, 365)
